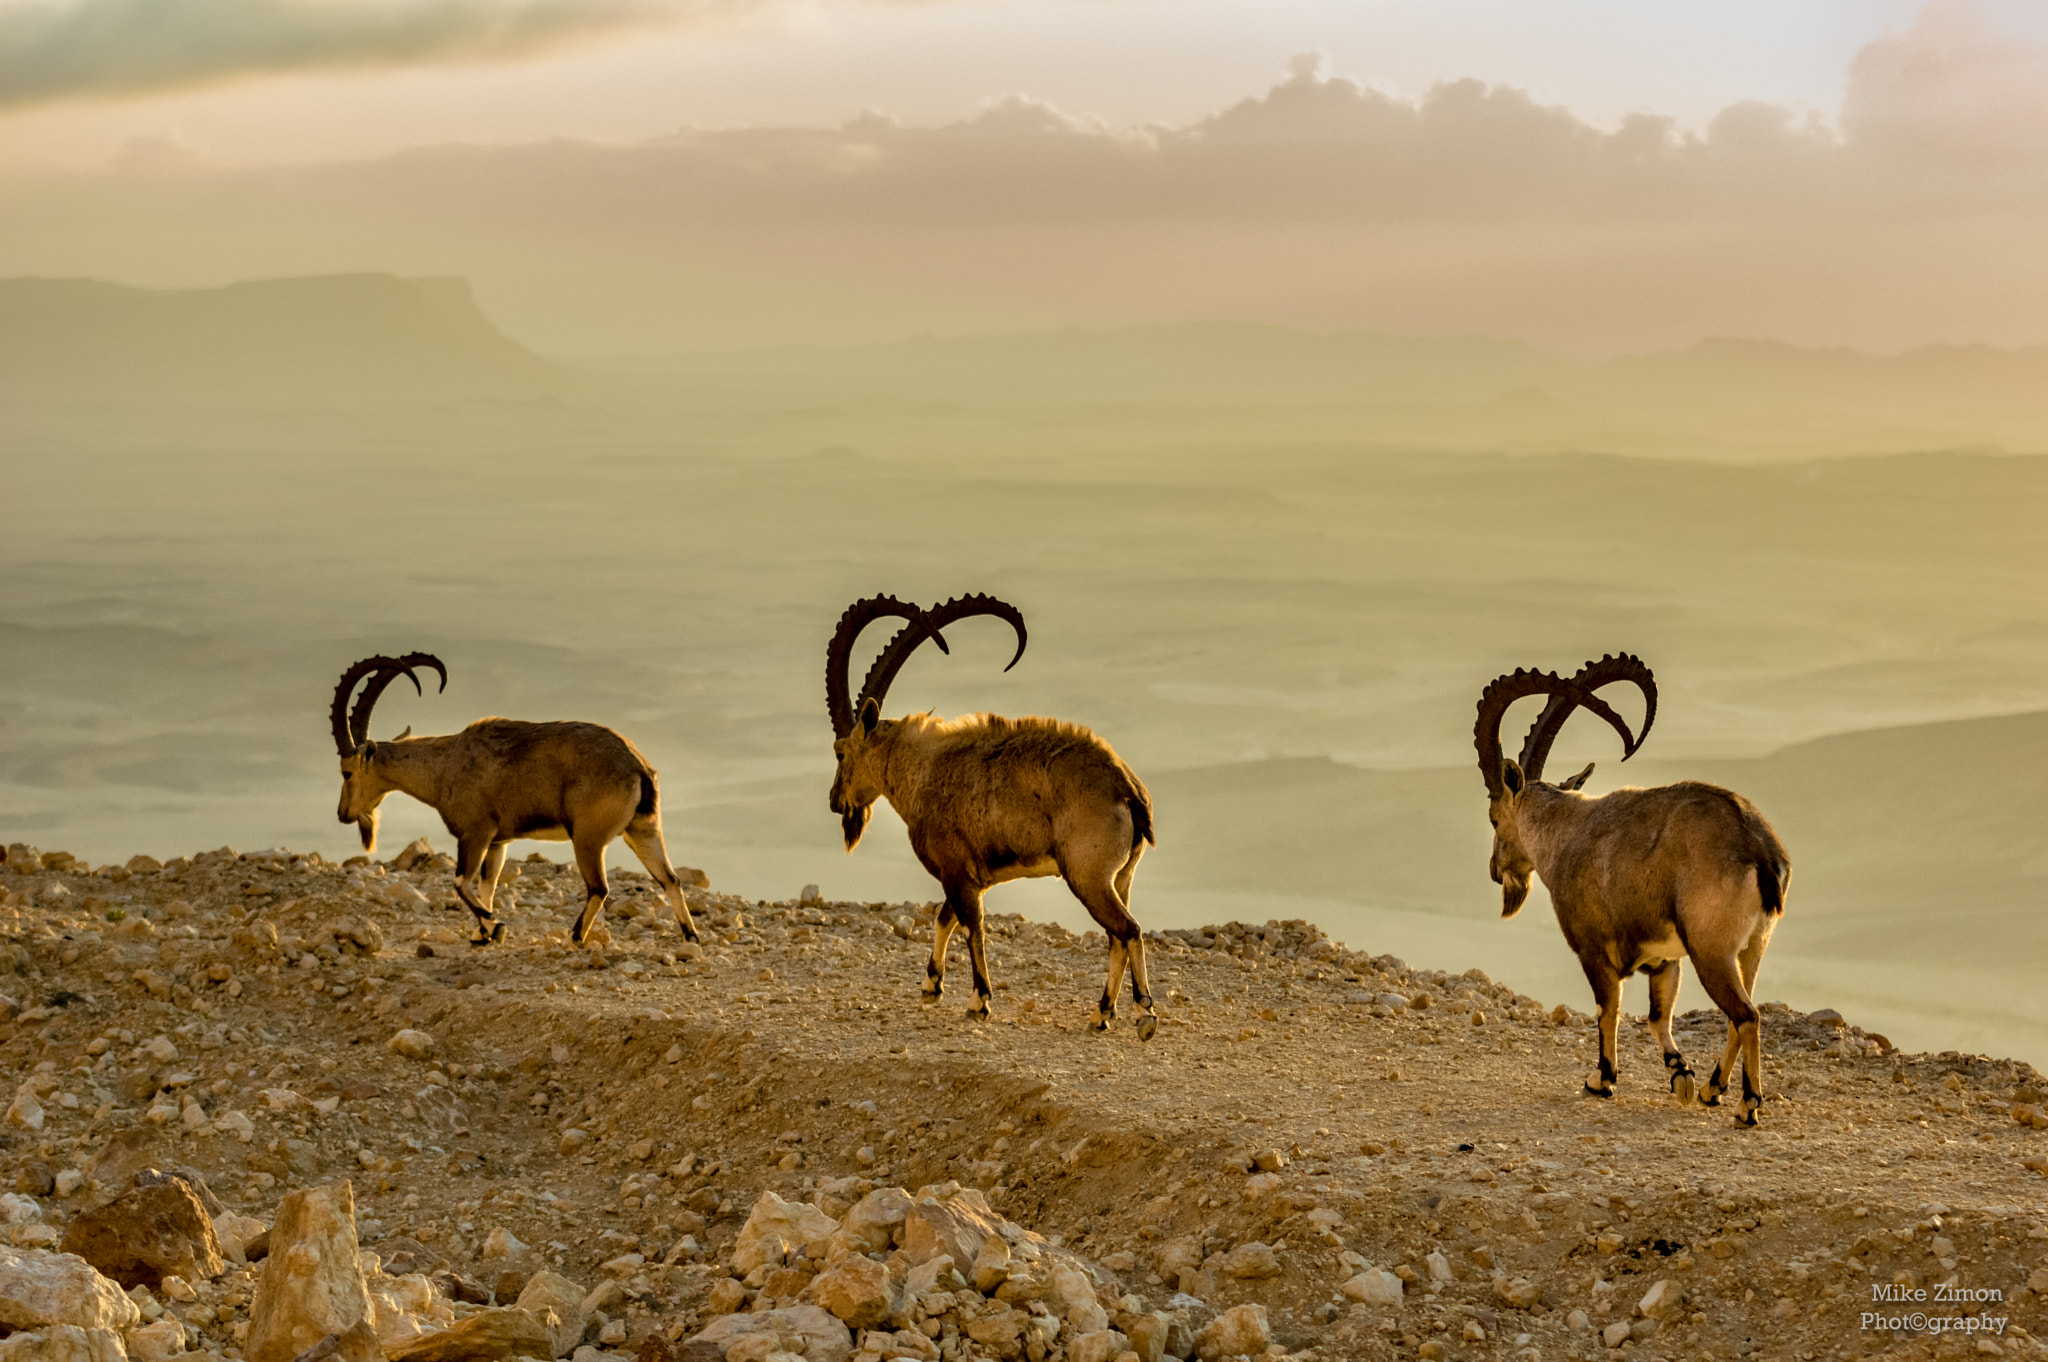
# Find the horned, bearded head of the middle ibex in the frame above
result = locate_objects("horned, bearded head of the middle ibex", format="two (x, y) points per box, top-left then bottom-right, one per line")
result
(825, 596), (1026, 850)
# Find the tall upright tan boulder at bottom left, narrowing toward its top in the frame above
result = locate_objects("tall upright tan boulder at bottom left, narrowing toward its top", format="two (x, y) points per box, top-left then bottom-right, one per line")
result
(242, 1180), (375, 1362)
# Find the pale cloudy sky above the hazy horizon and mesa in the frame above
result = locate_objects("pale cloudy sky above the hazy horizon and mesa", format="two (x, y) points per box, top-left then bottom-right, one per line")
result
(0, 0), (2048, 354)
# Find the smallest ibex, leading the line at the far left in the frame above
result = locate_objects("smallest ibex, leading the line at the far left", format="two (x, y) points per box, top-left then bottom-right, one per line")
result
(330, 653), (696, 946)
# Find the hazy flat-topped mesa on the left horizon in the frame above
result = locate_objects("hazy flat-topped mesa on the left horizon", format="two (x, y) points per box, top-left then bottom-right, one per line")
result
(0, 274), (559, 406)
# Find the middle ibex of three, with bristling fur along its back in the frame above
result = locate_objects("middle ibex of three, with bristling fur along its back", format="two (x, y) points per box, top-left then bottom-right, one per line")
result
(825, 596), (1159, 1040)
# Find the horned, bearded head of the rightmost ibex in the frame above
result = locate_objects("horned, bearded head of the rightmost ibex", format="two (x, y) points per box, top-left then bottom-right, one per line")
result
(1473, 653), (1657, 918)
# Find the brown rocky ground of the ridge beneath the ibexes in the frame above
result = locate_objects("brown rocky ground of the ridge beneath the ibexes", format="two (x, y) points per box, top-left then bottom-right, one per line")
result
(0, 844), (2048, 1362)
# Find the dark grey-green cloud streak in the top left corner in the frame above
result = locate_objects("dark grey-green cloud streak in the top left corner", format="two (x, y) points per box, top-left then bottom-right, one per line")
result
(0, 0), (704, 109)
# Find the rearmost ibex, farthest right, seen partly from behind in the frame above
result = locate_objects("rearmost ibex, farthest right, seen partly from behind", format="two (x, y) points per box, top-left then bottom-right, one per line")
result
(1475, 655), (1792, 1126)
